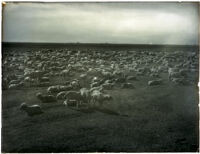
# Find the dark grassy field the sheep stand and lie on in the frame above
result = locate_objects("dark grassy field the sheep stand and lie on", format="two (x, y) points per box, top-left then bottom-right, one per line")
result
(2, 43), (199, 152)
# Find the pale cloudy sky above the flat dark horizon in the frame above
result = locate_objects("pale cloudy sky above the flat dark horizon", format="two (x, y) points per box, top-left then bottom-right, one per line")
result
(3, 2), (199, 45)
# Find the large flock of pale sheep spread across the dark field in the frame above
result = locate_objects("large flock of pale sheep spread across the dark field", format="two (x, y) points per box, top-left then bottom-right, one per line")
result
(2, 49), (198, 116)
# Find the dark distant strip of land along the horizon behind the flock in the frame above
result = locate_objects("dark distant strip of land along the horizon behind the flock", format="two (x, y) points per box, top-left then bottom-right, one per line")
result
(2, 42), (199, 51)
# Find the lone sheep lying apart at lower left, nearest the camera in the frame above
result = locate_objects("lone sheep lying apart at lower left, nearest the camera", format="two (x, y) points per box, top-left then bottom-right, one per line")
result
(20, 103), (44, 116)
